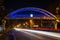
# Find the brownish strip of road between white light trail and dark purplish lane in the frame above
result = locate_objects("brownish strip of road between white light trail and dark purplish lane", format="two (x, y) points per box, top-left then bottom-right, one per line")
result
(23, 31), (60, 40)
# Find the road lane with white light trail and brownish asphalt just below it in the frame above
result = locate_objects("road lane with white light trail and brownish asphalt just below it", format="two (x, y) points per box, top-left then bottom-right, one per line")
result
(15, 29), (60, 40)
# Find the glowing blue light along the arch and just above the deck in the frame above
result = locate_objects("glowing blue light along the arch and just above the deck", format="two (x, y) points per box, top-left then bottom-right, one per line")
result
(6, 7), (55, 18)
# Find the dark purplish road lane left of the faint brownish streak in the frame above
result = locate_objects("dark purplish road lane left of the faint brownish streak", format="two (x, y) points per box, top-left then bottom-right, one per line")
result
(8, 30), (40, 40)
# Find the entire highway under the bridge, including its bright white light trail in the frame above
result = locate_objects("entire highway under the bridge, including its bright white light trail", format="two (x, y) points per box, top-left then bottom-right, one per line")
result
(8, 28), (60, 40)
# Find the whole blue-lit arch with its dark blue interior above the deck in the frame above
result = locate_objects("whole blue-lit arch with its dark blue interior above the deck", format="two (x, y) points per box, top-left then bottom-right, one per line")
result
(6, 7), (55, 19)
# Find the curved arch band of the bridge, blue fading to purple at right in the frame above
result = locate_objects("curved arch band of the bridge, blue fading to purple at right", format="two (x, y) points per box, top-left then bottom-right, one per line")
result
(5, 7), (56, 19)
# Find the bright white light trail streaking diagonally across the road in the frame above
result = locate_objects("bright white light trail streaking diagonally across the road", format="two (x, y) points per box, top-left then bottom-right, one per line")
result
(14, 28), (60, 38)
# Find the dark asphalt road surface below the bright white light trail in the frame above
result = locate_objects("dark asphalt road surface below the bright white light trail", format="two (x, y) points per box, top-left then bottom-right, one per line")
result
(7, 30), (60, 40)
